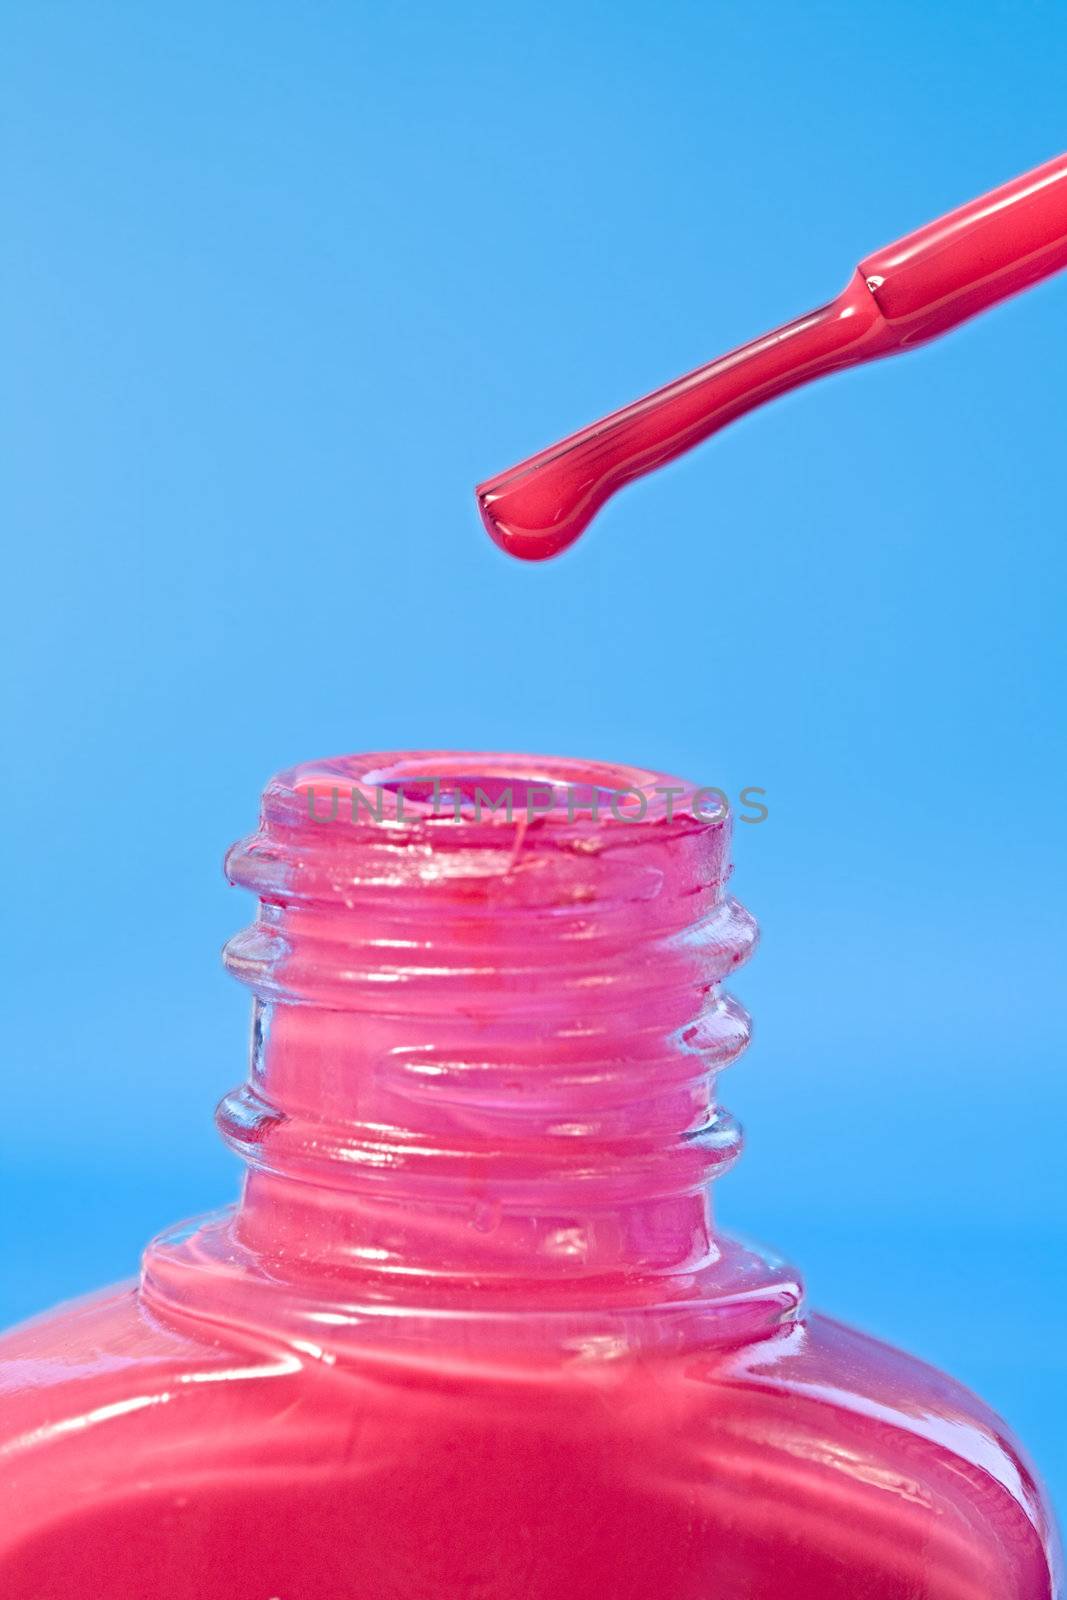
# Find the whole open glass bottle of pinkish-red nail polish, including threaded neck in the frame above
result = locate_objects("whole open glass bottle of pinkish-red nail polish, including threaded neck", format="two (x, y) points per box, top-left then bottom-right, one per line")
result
(0, 752), (1056, 1600)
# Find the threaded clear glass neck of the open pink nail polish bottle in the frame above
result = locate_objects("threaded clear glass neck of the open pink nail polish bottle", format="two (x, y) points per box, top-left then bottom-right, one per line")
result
(212, 755), (755, 1293)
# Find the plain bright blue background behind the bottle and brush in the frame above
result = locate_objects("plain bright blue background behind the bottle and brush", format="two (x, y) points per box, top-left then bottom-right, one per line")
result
(0, 0), (1067, 1501)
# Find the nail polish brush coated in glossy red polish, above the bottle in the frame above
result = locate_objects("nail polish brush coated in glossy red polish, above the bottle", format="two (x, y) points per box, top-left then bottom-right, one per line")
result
(477, 155), (1067, 562)
